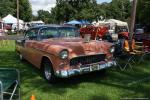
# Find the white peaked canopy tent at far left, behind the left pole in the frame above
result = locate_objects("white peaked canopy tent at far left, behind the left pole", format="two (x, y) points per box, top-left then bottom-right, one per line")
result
(2, 14), (24, 24)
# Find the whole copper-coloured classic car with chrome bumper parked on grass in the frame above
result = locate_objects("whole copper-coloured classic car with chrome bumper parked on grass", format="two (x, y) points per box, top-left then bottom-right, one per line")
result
(16, 25), (115, 82)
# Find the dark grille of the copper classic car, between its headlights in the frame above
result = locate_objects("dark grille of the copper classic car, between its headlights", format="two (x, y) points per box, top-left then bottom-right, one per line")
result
(70, 54), (106, 66)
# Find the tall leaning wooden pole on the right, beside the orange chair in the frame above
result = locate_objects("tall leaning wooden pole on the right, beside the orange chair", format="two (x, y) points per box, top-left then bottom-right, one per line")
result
(129, 0), (137, 51)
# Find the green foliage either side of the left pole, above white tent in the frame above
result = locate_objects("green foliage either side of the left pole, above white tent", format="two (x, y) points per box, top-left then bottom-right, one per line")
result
(0, 0), (32, 21)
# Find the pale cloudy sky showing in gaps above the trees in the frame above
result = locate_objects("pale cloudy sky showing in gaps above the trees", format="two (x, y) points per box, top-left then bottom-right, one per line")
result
(29, 0), (111, 15)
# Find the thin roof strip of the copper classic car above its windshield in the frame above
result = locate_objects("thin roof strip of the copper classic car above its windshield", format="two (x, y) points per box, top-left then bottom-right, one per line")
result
(30, 24), (75, 29)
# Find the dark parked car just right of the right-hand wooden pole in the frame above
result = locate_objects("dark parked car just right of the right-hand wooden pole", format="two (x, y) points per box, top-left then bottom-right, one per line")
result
(133, 28), (144, 42)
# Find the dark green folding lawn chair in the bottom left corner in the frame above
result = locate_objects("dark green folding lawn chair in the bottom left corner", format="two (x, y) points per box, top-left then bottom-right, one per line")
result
(0, 68), (20, 100)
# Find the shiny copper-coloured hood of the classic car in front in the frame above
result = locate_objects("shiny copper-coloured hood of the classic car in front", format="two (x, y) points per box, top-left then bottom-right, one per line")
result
(35, 38), (112, 58)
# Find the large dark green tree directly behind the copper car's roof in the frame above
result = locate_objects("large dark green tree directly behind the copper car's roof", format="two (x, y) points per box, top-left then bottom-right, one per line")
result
(51, 0), (97, 23)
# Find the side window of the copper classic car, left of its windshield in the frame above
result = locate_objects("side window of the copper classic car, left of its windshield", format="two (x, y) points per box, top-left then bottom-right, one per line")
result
(25, 29), (38, 40)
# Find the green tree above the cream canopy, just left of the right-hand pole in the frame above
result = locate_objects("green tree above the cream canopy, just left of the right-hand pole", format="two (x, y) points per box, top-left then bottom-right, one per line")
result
(101, 0), (131, 20)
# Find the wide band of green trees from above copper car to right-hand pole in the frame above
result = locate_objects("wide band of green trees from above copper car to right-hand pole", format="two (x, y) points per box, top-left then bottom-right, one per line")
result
(39, 0), (131, 23)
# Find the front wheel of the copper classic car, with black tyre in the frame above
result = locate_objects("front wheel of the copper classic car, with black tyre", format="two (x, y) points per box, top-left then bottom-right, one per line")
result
(42, 59), (56, 83)
